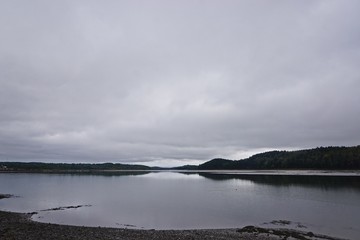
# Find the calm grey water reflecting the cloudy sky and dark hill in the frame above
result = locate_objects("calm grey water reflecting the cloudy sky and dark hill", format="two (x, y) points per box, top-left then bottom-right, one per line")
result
(0, 172), (360, 239)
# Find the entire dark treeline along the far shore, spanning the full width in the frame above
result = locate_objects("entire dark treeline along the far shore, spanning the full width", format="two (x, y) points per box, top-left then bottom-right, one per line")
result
(0, 146), (360, 172)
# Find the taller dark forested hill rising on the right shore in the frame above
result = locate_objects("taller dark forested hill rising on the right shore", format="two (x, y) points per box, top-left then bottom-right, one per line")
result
(198, 146), (360, 170)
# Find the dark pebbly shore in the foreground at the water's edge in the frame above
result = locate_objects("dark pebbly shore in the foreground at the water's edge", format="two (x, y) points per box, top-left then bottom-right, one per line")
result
(0, 194), (348, 240)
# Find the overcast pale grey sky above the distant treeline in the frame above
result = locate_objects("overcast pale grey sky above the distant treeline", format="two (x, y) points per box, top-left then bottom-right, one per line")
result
(0, 0), (360, 166)
